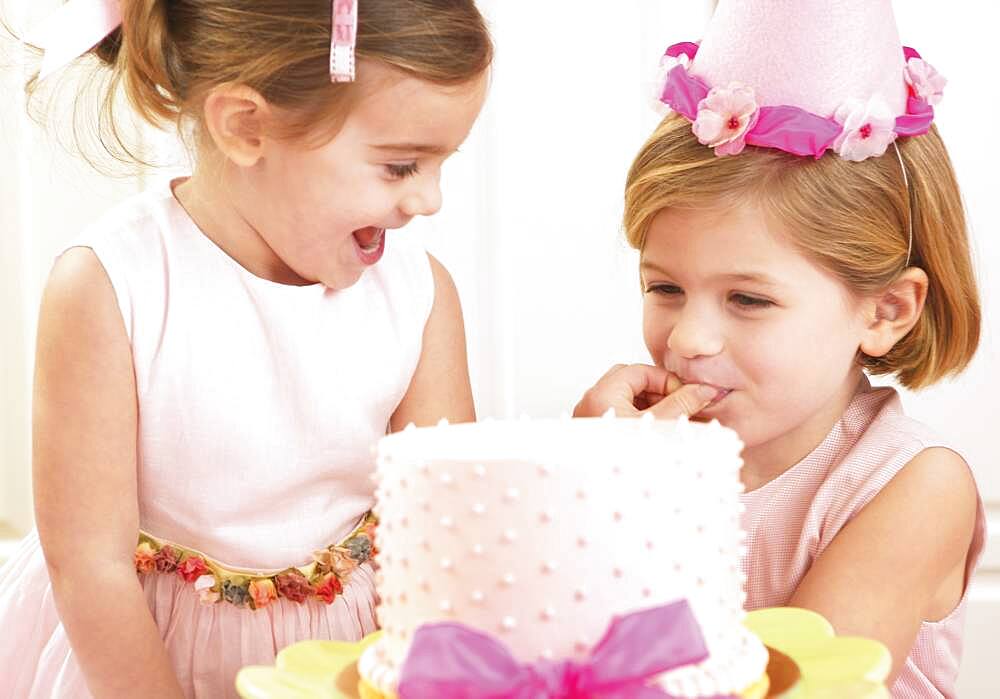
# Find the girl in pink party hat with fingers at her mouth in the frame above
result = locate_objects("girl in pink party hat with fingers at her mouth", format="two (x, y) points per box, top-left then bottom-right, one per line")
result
(576, 0), (985, 699)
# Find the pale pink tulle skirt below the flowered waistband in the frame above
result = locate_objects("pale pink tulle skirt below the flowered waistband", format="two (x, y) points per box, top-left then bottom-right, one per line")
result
(0, 532), (375, 699)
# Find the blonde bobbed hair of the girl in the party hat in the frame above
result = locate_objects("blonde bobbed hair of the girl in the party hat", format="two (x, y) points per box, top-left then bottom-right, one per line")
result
(624, 114), (981, 388)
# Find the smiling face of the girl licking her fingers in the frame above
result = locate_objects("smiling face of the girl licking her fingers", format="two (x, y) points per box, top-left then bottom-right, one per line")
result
(641, 203), (865, 465)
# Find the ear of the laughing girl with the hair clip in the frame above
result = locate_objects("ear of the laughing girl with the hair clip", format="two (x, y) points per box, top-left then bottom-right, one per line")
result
(204, 85), (270, 167)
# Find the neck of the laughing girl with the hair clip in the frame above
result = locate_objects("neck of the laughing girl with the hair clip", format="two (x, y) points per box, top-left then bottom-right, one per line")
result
(171, 163), (312, 286)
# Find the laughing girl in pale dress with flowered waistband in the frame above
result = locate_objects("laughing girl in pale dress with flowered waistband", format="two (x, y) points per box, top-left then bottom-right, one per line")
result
(0, 0), (492, 699)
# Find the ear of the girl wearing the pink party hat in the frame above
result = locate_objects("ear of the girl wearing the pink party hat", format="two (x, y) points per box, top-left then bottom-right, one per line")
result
(859, 267), (928, 357)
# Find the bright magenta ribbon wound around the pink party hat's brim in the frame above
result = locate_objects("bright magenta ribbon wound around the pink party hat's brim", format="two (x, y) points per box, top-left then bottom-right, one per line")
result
(660, 41), (934, 158)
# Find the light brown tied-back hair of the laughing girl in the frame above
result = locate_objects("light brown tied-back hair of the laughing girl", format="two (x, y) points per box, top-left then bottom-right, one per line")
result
(27, 0), (493, 161)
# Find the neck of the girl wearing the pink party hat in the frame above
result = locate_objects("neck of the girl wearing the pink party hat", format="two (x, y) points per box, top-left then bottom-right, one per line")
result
(740, 367), (868, 492)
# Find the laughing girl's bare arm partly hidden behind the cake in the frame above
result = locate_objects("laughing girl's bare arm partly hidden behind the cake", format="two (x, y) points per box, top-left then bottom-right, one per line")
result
(389, 257), (476, 432)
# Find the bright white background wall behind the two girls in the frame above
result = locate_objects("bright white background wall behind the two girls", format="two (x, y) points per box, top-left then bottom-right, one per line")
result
(0, 0), (1000, 698)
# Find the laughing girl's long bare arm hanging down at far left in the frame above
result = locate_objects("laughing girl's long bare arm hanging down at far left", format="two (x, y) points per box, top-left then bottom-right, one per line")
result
(33, 248), (183, 699)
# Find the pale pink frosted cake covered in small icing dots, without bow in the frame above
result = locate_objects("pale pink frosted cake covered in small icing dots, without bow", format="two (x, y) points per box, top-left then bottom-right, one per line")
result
(358, 418), (767, 697)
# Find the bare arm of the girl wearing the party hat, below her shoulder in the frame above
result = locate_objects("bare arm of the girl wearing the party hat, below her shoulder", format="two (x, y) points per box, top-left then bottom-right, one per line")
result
(789, 449), (978, 686)
